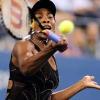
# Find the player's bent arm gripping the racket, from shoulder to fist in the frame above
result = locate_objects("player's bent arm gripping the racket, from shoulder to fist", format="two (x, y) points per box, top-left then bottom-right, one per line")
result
(13, 36), (67, 75)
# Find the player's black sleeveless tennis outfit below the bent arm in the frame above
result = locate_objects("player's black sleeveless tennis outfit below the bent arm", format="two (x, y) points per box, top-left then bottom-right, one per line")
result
(6, 52), (59, 100)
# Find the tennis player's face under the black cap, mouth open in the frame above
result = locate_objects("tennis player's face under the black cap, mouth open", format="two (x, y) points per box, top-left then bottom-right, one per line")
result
(34, 8), (55, 31)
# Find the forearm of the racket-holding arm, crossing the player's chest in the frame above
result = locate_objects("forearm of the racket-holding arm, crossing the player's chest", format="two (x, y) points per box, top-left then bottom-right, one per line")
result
(23, 46), (57, 74)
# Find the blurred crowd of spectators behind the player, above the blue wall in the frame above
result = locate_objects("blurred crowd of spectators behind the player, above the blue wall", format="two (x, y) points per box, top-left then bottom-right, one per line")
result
(0, 0), (100, 58)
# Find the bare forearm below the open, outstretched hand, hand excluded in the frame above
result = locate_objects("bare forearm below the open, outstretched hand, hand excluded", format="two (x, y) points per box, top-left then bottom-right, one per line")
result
(51, 81), (85, 100)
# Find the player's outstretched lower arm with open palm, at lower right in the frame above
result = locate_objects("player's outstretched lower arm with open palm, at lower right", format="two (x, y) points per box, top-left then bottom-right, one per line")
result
(51, 75), (100, 100)
